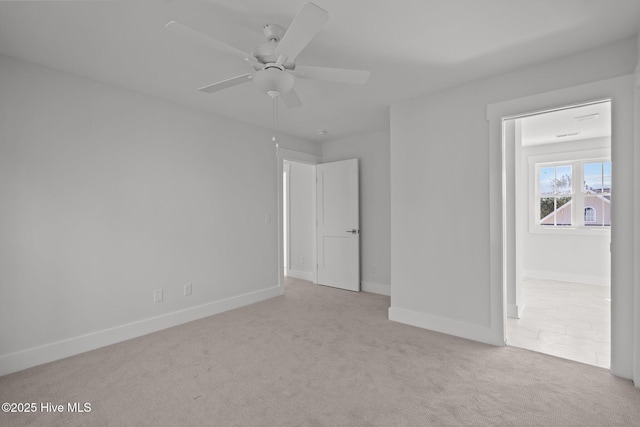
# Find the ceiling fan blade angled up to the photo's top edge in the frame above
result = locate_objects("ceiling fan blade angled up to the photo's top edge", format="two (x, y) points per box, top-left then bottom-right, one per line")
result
(274, 3), (329, 61)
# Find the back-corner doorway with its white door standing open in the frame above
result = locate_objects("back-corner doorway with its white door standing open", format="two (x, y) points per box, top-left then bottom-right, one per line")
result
(276, 146), (360, 291)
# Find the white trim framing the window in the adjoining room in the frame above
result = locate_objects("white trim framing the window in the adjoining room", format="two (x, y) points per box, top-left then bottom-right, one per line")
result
(527, 148), (611, 235)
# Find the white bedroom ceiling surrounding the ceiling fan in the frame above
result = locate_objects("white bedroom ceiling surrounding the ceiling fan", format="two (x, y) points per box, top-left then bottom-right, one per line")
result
(0, 0), (640, 141)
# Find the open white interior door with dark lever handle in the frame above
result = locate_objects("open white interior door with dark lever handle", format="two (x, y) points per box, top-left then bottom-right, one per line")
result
(316, 159), (360, 292)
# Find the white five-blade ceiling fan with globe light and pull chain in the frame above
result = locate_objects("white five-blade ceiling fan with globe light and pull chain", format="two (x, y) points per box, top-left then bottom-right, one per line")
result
(165, 3), (369, 108)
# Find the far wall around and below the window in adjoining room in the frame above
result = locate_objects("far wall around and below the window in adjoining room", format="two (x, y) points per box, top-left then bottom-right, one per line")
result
(517, 137), (615, 286)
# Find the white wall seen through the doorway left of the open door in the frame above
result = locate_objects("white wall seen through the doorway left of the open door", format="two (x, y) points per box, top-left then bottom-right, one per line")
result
(288, 162), (316, 281)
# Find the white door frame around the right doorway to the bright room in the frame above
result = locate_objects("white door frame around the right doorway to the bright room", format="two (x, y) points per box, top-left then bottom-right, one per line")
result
(487, 75), (640, 380)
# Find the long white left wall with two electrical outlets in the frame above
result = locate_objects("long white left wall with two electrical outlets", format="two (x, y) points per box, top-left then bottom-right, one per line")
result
(0, 56), (311, 375)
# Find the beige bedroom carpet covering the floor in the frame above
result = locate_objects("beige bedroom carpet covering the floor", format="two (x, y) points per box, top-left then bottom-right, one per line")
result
(0, 281), (640, 426)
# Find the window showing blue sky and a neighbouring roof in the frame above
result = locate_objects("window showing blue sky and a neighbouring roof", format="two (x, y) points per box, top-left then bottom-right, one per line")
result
(534, 159), (611, 229)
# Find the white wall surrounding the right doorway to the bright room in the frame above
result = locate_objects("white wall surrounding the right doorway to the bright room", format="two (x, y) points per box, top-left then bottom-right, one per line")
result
(389, 38), (637, 376)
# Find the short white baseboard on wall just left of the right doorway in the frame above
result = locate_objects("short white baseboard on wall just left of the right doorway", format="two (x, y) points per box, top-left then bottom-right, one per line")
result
(389, 307), (505, 346)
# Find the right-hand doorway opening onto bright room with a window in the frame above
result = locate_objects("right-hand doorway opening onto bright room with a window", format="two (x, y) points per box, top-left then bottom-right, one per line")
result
(503, 100), (612, 368)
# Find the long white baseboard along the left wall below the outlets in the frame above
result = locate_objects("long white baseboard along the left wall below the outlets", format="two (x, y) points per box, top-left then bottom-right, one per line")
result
(0, 286), (284, 376)
